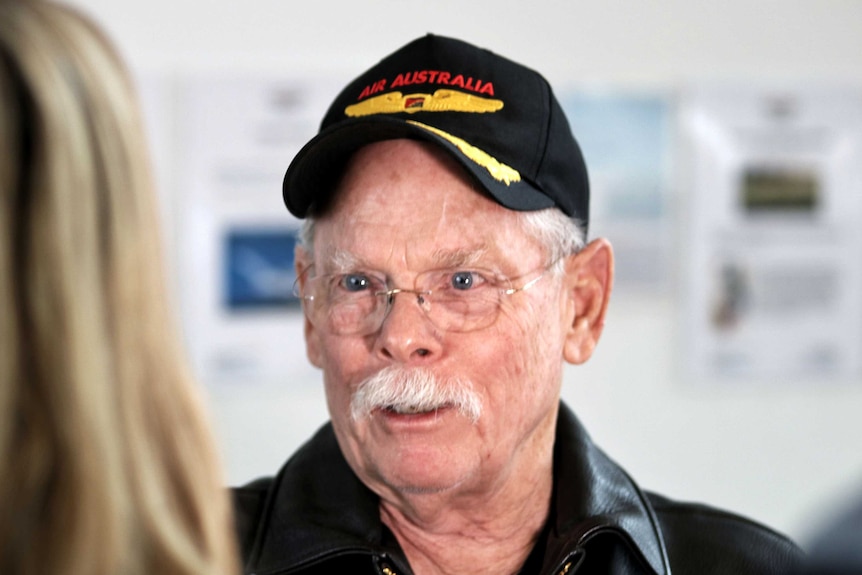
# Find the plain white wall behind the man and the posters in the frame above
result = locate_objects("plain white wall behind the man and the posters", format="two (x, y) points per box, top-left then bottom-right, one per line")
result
(66, 0), (862, 541)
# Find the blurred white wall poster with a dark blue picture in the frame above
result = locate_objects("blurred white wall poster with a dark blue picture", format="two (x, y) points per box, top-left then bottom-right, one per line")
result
(175, 75), (338, 383)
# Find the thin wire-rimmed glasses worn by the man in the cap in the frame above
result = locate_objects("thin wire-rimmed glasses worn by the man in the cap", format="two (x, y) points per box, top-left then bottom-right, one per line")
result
(293, 264), (553, 335)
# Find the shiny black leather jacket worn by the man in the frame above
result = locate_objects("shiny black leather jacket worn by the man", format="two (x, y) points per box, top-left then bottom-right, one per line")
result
(234, 405), (802, 575)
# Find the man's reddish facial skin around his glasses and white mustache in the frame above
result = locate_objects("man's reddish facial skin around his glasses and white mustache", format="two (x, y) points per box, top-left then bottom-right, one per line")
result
(306, 140), (566, 497)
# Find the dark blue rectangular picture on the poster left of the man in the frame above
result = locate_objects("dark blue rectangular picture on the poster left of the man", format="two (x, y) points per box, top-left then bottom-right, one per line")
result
(224, 228), (299, 310)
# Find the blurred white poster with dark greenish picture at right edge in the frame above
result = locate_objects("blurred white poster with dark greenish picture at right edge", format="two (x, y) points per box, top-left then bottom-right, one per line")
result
(680, 87), (862, 383)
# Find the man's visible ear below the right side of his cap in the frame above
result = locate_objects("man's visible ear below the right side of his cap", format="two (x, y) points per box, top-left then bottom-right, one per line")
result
(563, 238), (614, 364)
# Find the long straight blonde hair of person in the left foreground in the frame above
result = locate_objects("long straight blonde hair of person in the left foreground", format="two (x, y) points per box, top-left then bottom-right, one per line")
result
(0, 0), (238, 575)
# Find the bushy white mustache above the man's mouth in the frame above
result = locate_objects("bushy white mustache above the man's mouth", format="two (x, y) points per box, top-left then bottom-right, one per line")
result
(350, 366), (482, 423)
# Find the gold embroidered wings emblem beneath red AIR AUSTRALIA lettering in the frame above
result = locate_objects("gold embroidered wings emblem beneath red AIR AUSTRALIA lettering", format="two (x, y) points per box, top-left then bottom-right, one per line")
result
(344, 89), (503, 118)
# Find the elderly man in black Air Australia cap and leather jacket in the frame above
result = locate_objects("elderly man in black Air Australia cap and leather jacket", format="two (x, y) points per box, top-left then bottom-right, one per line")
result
(235, 35), (799, 575)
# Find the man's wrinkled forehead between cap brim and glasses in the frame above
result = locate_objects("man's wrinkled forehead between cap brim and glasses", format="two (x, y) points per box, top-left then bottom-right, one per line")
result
(306, 140), (541, 267)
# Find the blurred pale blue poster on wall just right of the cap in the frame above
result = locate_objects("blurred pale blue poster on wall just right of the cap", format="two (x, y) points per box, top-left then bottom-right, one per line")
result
(560, 90), (673, 292)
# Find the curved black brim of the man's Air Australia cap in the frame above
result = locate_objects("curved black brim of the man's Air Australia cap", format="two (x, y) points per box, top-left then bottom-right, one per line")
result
(282, 116), (555, 218)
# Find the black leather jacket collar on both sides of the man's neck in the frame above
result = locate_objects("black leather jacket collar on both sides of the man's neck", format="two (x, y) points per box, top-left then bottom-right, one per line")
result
(250, 403), (669, 575)
